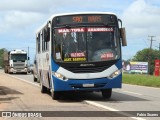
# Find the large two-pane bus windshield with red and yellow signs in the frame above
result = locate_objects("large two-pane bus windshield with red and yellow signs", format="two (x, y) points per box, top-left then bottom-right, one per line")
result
(54, 27), (120, 62)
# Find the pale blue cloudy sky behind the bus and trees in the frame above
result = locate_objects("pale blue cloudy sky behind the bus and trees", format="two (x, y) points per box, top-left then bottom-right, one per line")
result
(0, 0), (160, 63)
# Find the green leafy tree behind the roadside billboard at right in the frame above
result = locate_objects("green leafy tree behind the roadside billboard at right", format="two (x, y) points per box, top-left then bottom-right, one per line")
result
(132, 48), (160, 74)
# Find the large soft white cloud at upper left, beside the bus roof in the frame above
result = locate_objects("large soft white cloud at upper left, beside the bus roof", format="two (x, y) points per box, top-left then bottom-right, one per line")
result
(0, 11), (43, 34)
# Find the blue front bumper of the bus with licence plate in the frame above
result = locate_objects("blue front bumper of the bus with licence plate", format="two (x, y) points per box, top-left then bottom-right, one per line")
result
(52, 74), (122, 91)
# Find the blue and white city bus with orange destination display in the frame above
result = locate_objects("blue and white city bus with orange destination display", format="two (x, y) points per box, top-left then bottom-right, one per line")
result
(36, 12), (127, 99)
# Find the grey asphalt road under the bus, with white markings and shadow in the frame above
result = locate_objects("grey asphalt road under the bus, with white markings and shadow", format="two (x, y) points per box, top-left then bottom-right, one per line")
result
(0, 70), (160, 120)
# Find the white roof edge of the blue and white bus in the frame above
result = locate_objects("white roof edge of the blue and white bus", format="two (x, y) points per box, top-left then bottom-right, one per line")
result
(36, 12), (116, 33)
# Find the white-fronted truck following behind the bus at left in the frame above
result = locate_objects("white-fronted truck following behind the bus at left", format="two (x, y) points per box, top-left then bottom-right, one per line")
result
(4, 49), (29, 74)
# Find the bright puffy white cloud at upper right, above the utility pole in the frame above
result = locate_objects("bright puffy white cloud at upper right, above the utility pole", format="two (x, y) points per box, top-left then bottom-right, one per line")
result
(122, 0), (160, 38)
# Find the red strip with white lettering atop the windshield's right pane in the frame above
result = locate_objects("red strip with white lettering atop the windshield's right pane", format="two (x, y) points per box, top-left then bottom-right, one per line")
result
(87, 27), (114, 32)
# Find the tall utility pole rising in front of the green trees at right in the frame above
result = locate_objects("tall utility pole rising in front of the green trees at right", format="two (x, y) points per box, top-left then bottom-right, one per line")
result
(148, 36), (155, 74)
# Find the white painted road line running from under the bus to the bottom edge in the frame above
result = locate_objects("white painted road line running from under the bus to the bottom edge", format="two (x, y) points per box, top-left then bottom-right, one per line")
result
(84, 100), (146, 120)
